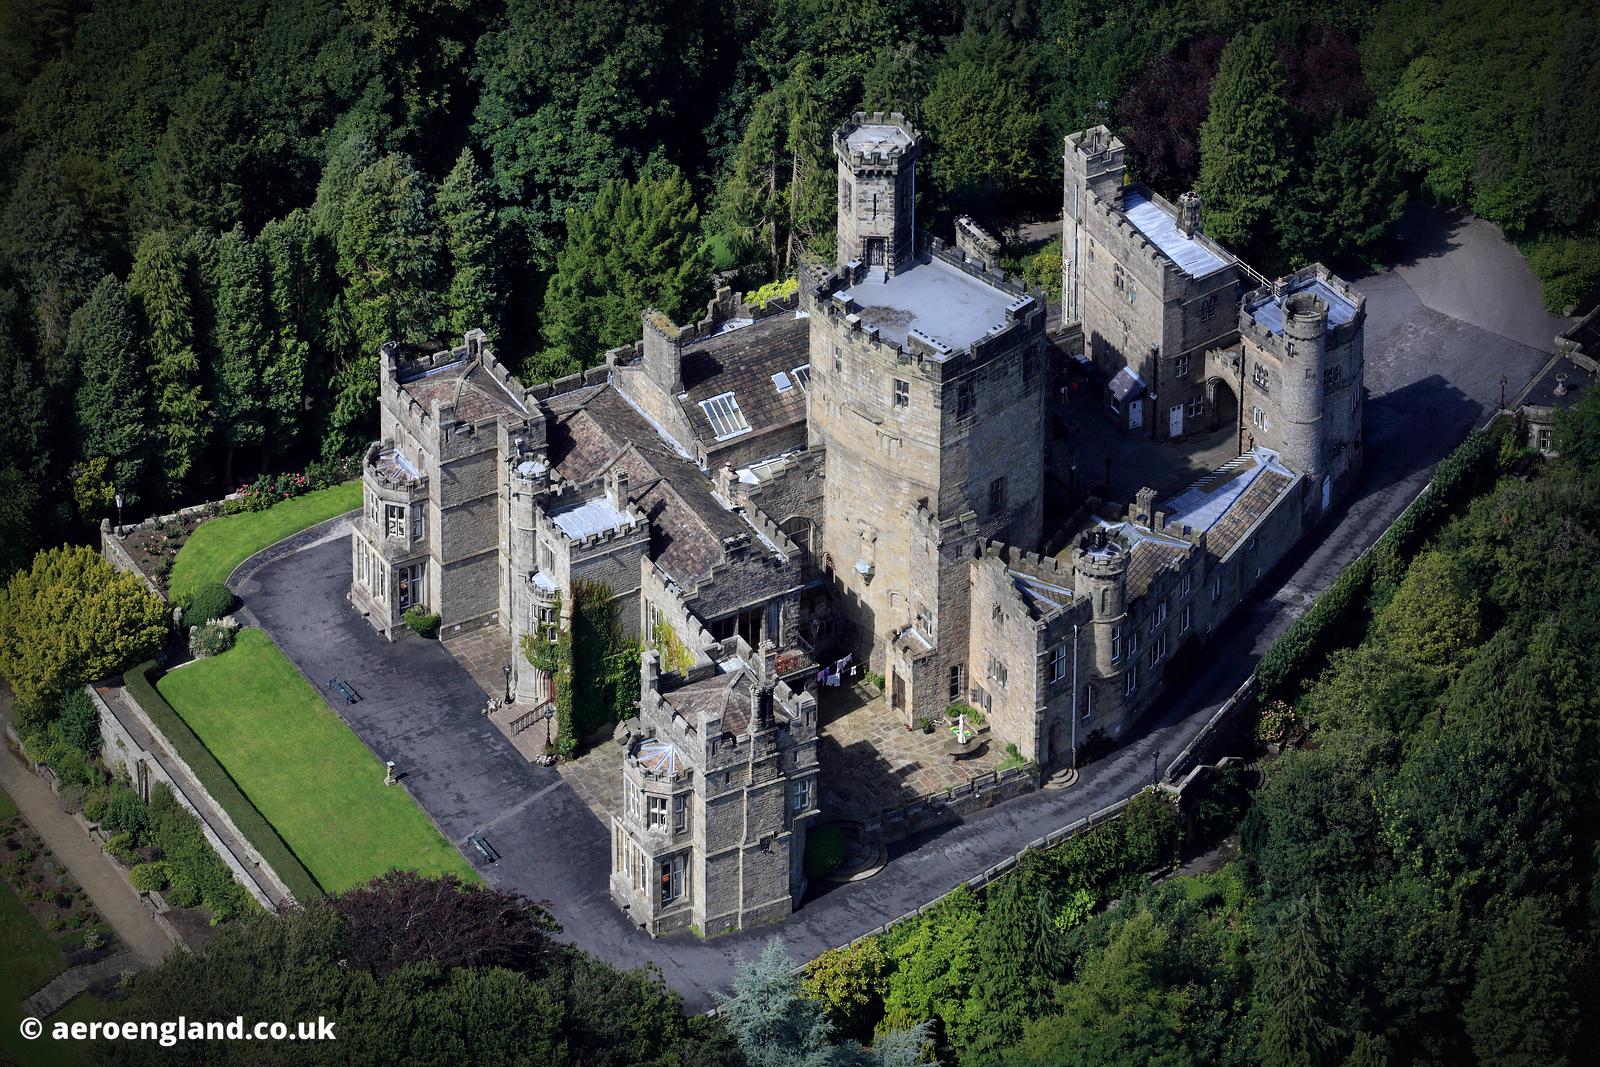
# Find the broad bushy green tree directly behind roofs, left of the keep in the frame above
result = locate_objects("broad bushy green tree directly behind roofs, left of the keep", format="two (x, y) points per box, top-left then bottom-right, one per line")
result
(534, 170), (710, 376)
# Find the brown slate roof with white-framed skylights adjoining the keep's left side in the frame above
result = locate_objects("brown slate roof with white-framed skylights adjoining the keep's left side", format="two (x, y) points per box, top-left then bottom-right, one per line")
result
(678, 312), (811, 450)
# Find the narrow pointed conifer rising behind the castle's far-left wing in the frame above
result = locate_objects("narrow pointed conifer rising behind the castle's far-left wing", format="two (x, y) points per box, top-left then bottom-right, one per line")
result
(438, 149), (501, 338)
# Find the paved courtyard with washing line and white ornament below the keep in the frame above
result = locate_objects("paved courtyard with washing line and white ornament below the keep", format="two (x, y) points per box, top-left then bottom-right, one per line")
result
(818, 681), (1005, 822)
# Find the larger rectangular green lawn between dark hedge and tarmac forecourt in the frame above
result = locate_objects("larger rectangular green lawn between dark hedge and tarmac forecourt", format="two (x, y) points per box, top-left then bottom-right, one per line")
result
(157, 629), (477, 893)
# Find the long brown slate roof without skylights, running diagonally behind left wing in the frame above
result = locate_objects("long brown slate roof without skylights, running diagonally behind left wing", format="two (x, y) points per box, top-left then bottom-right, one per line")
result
(549, 386), (777, 587)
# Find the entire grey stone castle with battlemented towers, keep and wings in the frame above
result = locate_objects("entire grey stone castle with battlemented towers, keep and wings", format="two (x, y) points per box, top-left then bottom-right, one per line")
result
(350, 114), (1363, 934)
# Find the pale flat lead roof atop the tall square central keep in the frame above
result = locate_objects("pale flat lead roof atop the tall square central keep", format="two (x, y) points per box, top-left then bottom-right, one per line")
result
(843, 258), (1018, 349)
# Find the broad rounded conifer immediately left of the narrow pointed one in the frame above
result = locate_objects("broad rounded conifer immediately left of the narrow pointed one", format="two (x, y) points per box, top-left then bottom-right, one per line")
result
(338, 154), (442, 354)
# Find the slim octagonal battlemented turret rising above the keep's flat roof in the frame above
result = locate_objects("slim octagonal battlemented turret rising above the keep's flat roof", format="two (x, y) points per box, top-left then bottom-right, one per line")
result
(834, 112), (922, 277)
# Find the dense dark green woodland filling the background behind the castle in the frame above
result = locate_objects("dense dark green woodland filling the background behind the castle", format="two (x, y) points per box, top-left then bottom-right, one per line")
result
(0, 0), (1600, 571)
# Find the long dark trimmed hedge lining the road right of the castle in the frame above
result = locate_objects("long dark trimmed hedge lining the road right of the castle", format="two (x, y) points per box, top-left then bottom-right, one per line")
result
(1256, 422), (1507, 702)
